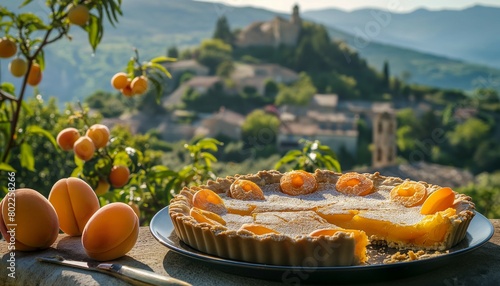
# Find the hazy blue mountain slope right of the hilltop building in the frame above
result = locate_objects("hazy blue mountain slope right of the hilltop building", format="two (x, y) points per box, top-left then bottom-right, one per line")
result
(304, 5), (500, 68)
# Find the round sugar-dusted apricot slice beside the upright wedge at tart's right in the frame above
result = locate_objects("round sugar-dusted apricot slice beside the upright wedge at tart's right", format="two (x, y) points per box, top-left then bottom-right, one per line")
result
(391, 181), (427, 208)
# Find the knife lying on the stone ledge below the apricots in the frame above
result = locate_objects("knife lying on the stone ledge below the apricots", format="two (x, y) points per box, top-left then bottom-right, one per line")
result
(37, 256), (191, 286)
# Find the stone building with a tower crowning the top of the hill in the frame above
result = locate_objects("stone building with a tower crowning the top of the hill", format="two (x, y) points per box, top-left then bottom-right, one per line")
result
(236, 5), (302, 47)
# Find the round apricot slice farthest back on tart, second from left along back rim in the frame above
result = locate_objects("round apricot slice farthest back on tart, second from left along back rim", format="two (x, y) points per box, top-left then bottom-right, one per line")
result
(280, 170), (318, 196)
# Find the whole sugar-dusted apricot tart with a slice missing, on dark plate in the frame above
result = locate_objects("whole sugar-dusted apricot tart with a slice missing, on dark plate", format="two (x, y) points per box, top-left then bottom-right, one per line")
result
(169, 170), (474, 266)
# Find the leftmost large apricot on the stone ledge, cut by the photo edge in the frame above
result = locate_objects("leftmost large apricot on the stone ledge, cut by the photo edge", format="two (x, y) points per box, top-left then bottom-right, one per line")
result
(0, 189), (59, 251)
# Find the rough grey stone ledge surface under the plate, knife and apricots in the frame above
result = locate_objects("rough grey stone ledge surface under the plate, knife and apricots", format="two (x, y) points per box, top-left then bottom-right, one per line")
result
(0, 219), (500, 286)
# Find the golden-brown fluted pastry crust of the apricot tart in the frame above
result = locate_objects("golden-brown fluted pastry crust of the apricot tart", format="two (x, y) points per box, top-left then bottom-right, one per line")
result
(169, 170), (474, 266)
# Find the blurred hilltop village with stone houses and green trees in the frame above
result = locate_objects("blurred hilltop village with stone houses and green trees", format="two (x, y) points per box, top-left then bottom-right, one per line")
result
(94, 6), (496, 188)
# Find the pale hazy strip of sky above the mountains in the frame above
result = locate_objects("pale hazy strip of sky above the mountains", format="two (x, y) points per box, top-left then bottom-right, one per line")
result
(198, 0), (500, 12)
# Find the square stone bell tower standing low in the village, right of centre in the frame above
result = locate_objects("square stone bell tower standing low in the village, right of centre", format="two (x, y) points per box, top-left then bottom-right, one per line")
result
(372, 111), (397, 168)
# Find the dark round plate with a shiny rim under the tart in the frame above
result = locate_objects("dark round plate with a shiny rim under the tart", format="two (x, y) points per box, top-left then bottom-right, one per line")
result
(149, 207), (494, 284)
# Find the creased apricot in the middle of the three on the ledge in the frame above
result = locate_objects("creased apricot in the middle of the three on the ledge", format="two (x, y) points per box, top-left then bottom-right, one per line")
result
(49, 178), (99, 236)
